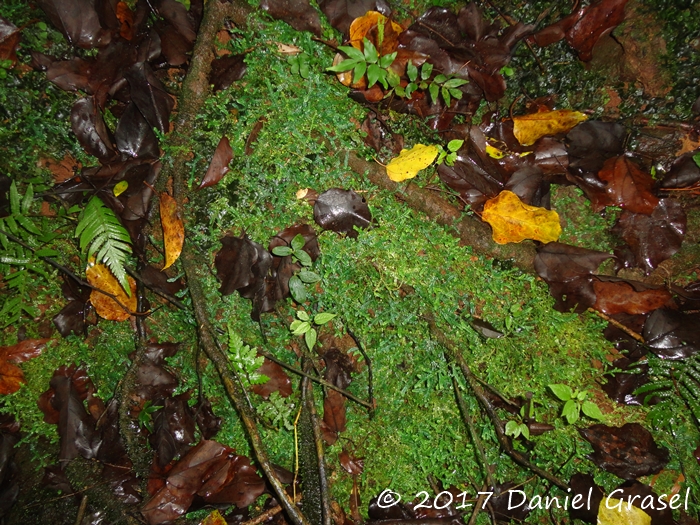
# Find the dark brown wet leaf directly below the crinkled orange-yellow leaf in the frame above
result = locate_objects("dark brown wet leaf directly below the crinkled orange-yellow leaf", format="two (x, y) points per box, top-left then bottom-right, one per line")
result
(535, 242), (612, 312)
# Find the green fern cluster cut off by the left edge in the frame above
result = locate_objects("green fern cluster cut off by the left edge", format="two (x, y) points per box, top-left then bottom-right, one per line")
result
(0, 181), (58, 329)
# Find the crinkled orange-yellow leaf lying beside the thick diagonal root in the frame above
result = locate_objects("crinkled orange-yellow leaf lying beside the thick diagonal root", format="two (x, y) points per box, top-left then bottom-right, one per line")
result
(482, 190), (561, 244)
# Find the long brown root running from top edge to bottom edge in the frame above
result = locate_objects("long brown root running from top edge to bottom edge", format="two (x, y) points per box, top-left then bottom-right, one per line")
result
(157, 0), (309, 525)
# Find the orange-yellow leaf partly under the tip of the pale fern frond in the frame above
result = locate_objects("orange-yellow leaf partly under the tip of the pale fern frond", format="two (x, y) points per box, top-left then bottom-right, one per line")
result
(85, 262), (137, 321)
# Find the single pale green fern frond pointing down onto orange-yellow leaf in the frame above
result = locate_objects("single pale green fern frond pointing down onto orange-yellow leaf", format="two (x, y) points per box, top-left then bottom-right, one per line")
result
(75, 196), (131, 297)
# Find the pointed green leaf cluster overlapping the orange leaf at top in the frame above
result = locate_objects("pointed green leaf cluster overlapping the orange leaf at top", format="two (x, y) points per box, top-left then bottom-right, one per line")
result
(328, 38), (401, 89)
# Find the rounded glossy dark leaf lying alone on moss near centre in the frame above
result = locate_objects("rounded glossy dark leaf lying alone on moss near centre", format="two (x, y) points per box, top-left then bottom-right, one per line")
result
(314, 188), (372, 239)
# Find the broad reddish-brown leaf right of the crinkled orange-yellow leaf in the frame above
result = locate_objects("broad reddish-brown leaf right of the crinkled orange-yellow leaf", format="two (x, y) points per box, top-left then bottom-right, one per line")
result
(589, 157), (659, 215)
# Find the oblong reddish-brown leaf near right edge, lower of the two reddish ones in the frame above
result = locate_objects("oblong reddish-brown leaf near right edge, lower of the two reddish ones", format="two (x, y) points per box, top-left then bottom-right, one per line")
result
(593, 276), (675, 315)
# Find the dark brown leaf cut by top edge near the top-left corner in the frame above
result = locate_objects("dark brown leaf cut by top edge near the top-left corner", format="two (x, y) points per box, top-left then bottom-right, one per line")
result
(37, 0), (110, 49)
